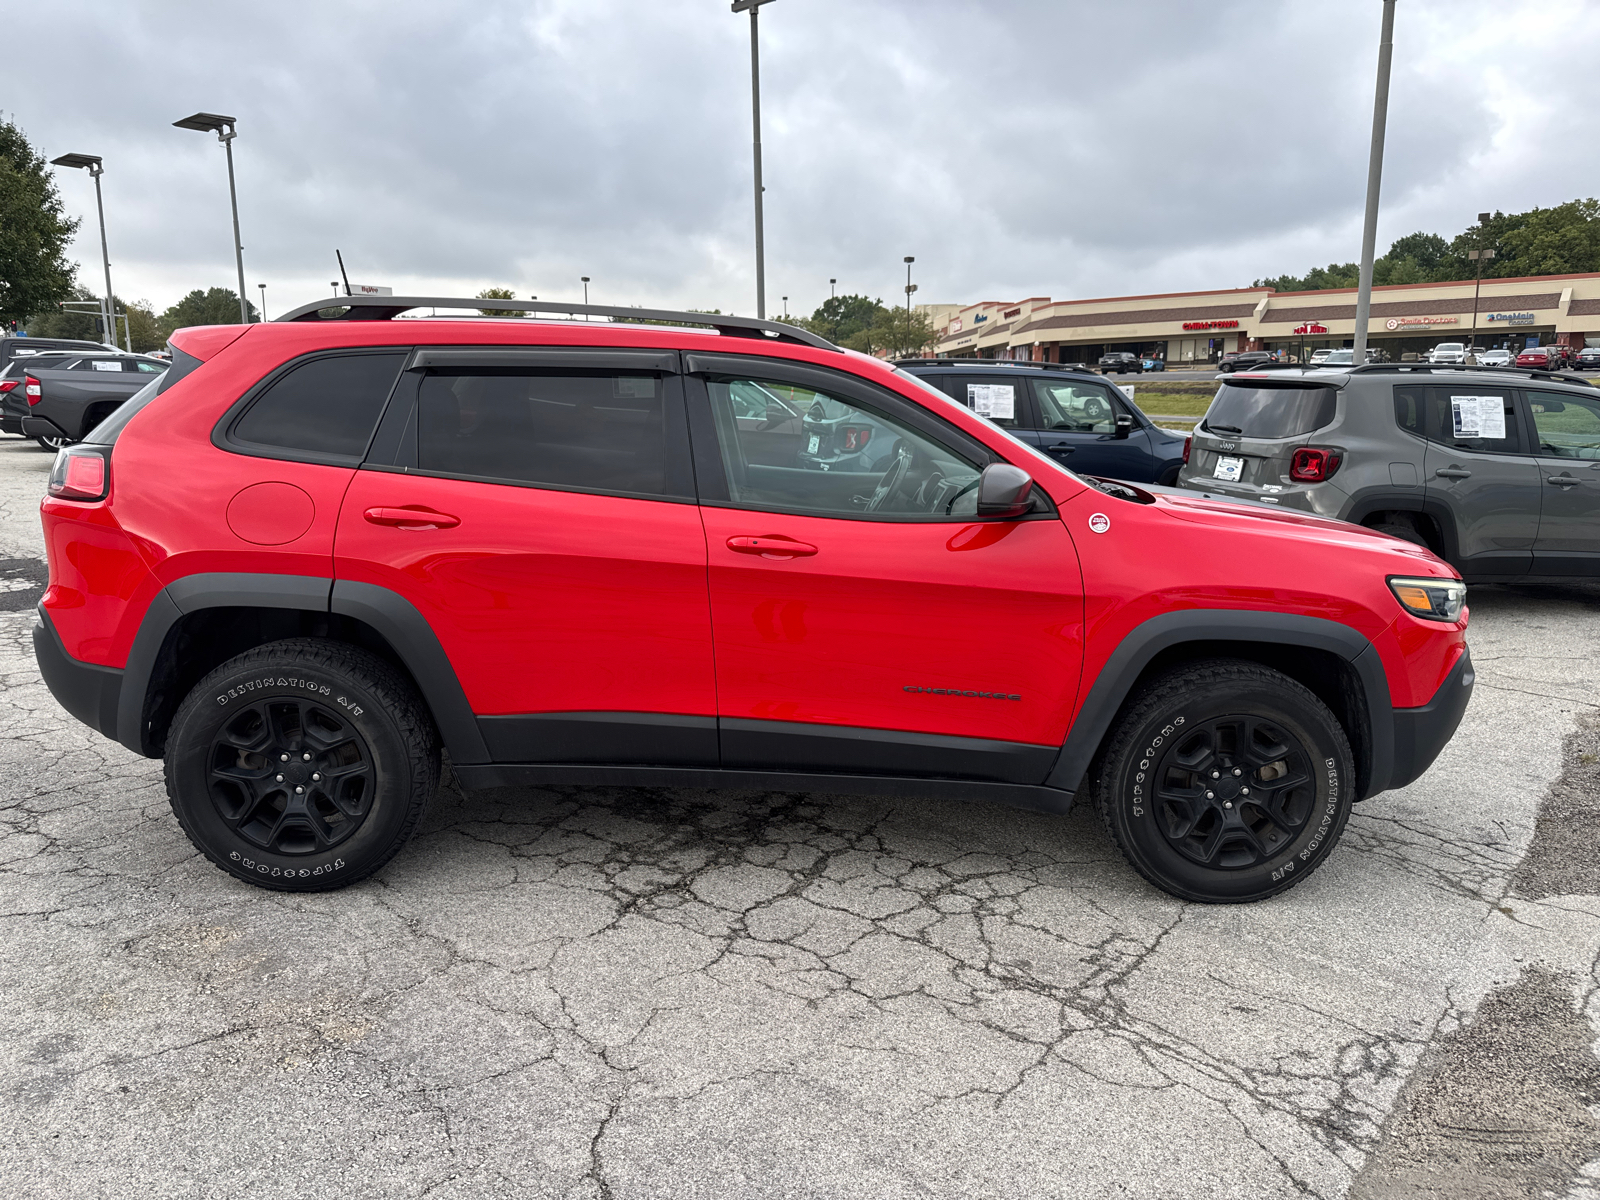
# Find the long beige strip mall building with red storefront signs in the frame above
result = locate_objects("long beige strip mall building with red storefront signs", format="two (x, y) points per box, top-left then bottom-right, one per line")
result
(923, 274), (1600, 366)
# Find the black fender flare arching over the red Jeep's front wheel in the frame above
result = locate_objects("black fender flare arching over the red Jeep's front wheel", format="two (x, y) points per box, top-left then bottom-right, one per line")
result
(1045, 608), (1395, 798)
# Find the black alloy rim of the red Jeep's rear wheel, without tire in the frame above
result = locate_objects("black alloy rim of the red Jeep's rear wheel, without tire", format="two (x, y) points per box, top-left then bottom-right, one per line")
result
(210, 698), (374, 854)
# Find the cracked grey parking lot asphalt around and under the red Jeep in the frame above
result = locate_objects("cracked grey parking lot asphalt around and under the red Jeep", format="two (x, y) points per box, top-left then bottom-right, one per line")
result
(0, 438), (1600, 1198)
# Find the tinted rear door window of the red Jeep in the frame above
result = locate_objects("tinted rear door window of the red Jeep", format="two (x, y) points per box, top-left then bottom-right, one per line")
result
(416, 366), (672, 496)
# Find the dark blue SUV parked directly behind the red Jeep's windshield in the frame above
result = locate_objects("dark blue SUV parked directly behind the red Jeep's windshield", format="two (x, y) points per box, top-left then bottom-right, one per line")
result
(894, 358), (1184, 486)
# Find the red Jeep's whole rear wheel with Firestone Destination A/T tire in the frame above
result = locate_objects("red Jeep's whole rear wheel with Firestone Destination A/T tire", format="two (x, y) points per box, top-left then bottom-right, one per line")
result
(166, 638), (440, 891)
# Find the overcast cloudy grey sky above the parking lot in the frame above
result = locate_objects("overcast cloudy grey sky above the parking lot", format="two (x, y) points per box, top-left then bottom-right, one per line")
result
(12, 0), (1600, 315)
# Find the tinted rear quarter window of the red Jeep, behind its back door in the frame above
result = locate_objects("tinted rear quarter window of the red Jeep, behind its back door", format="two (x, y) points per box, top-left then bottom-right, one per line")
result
(232, 350), (406, 461)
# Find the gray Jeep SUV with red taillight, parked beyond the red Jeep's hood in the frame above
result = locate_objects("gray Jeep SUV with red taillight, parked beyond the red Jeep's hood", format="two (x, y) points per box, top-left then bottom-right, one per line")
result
(1178, 363), (1600, 582)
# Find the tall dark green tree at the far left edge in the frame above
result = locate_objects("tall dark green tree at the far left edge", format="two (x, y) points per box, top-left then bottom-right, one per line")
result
(0, 122), (78, 322)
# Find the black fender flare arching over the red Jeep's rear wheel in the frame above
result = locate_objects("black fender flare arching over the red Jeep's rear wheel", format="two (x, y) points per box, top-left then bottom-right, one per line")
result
(117, 571), (490, 763)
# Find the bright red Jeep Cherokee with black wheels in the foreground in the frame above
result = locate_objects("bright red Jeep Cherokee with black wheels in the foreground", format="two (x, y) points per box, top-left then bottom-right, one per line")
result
(34, 296), (1472, 901)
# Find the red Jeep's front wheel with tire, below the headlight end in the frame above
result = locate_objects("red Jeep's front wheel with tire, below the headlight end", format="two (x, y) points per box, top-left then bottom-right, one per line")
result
(1093, 659), (1355, 904)
